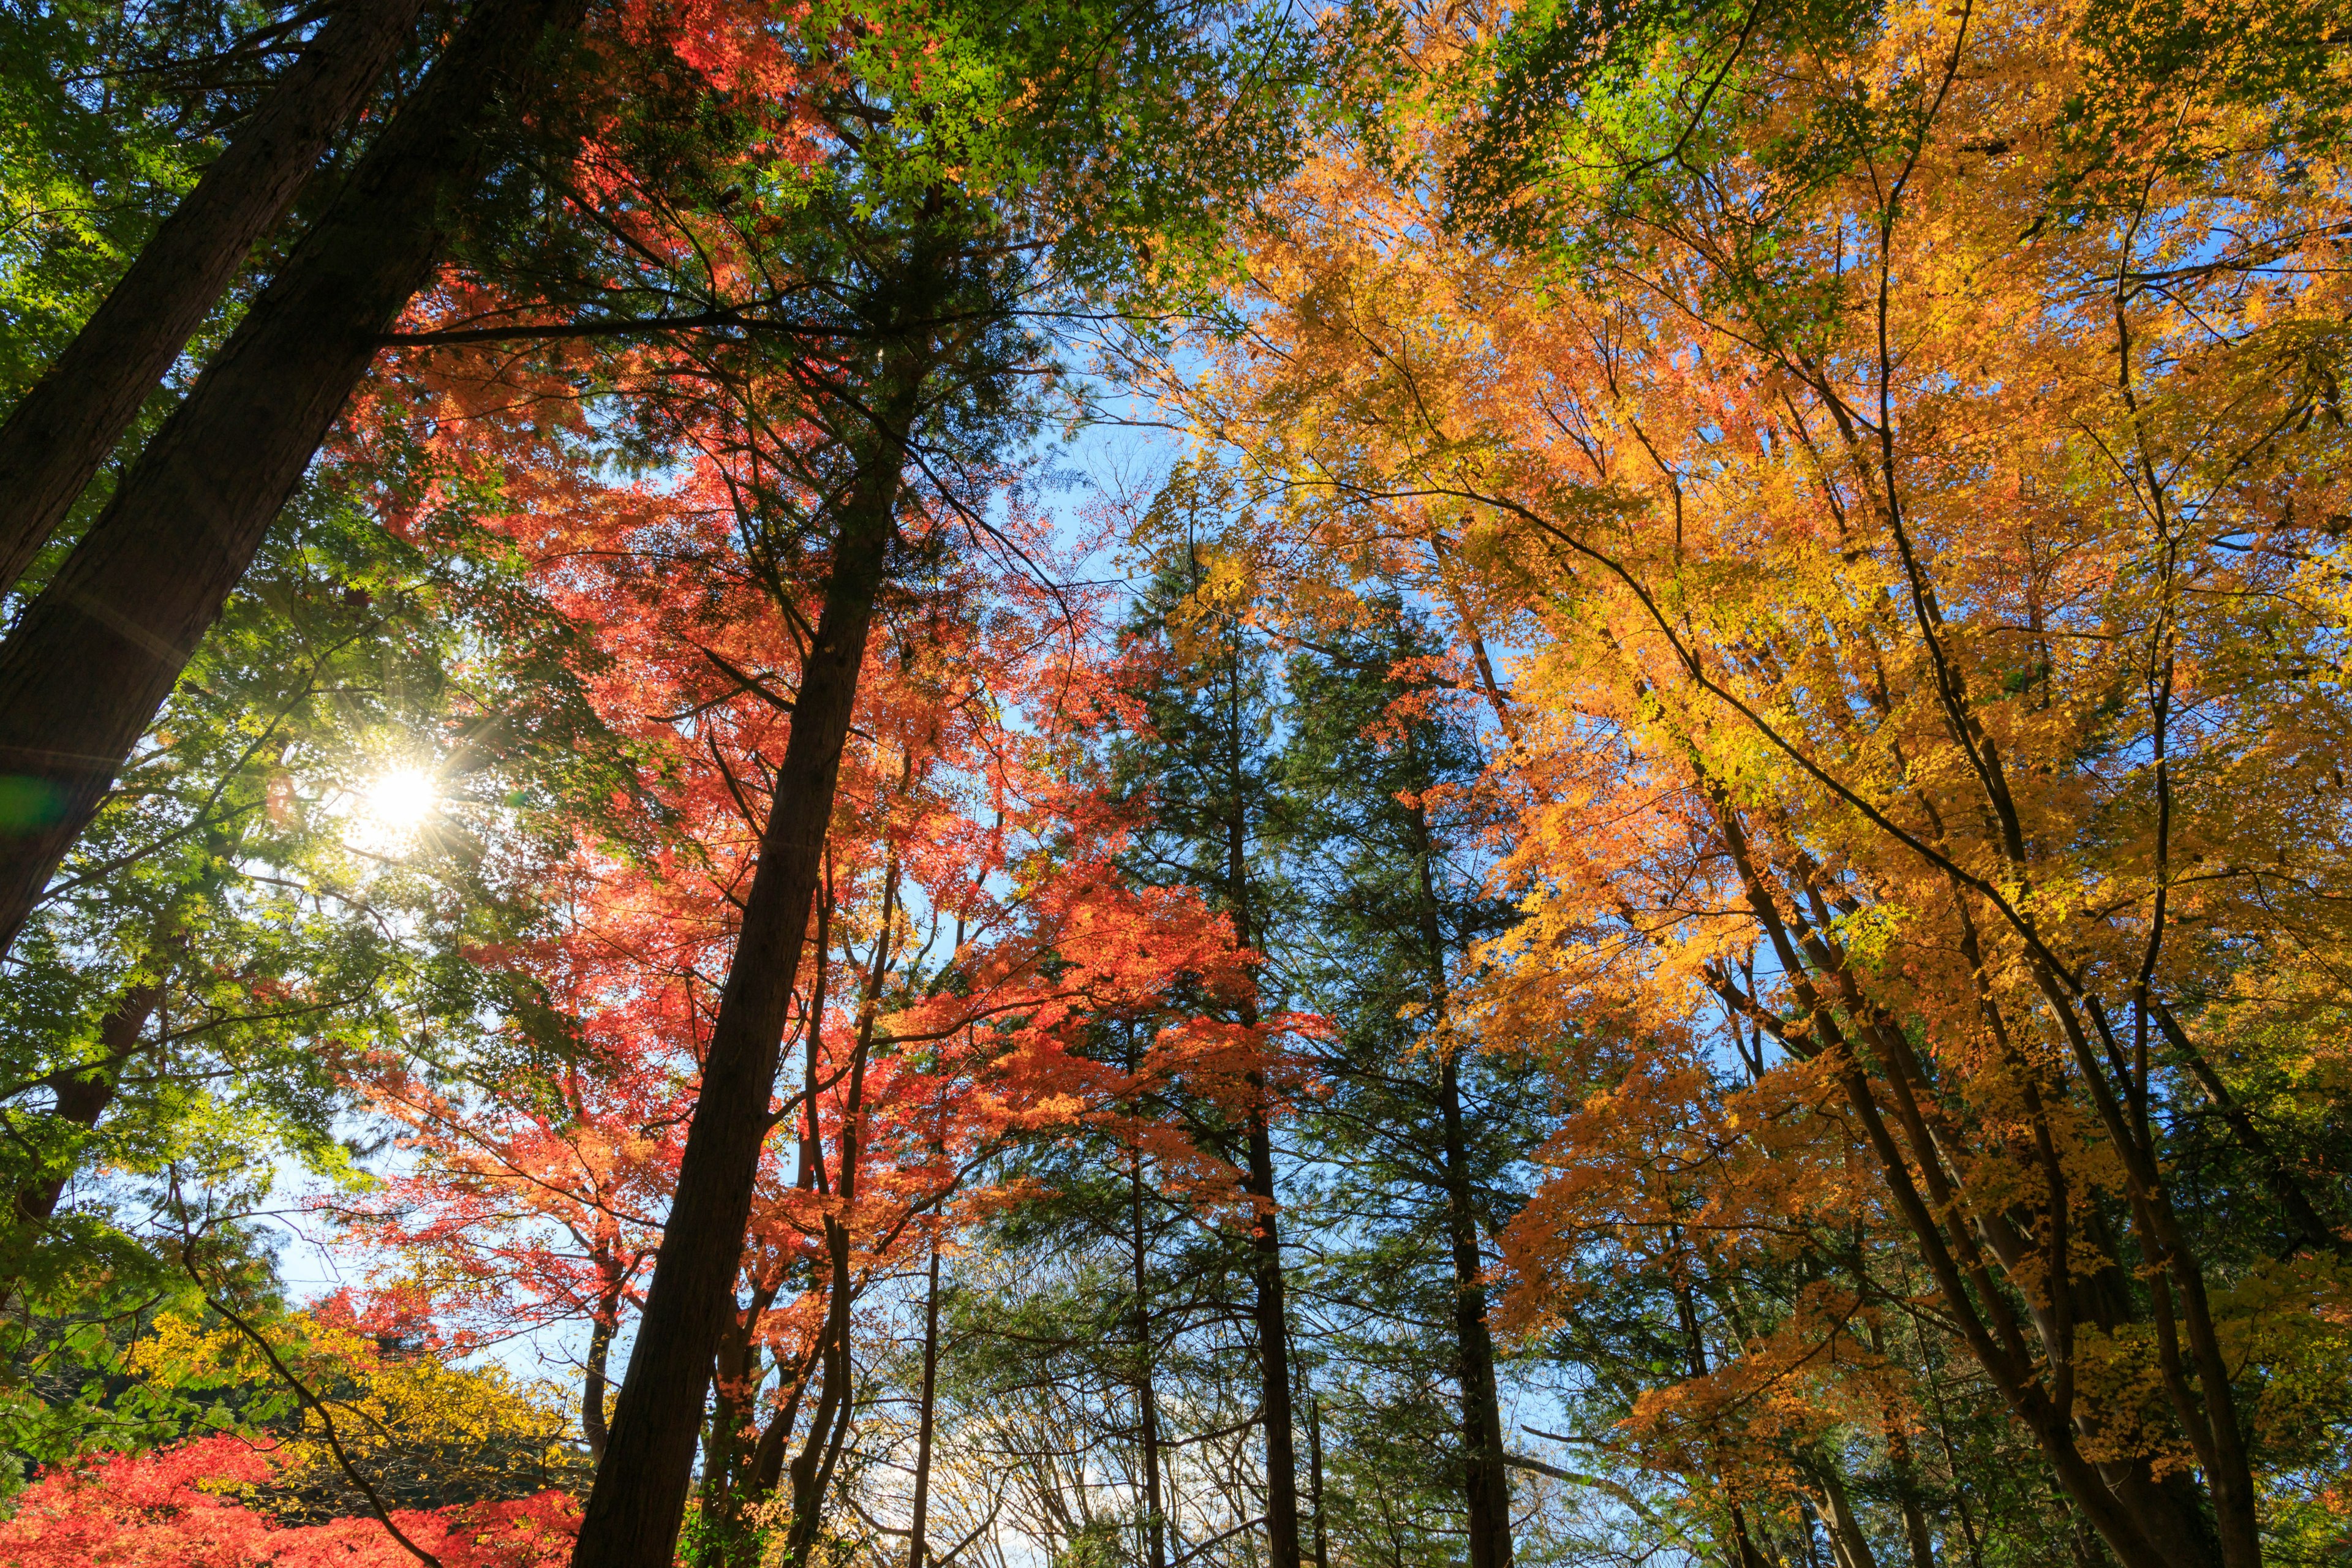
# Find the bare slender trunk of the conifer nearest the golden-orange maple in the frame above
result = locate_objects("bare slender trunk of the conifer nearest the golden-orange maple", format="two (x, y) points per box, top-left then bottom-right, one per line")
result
(1411, 799), (1510, 1568)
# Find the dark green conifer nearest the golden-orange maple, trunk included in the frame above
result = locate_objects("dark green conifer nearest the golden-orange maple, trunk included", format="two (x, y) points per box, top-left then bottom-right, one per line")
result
(1268, 600), (1540, 1568)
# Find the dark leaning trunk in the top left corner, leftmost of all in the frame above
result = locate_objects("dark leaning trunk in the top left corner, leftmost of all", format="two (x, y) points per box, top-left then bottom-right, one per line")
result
(0, 0), (423, 590)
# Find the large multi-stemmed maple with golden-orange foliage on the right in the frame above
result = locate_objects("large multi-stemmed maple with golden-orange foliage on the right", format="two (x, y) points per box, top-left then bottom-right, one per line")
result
(1166, 9), (2343, 1566)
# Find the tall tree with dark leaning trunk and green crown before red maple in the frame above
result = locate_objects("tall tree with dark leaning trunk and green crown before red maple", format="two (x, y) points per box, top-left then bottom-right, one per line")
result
(362, 7), (1326, 1561)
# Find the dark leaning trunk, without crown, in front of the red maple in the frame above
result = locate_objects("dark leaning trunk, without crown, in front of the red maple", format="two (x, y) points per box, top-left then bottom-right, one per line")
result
(571, 338), (929, 1568)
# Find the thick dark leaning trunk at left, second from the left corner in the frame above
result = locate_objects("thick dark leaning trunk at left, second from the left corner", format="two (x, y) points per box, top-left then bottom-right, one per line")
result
(0, 0), (586, 952)
